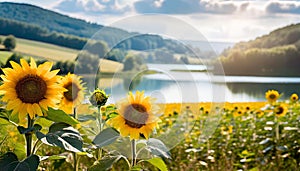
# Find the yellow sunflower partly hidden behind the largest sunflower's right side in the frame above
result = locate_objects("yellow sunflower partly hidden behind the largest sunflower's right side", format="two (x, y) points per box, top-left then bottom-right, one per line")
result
(59, 73), (84, 114)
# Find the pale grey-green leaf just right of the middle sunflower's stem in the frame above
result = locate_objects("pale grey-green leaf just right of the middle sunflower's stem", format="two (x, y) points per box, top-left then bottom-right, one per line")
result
(139, 138), (171, 159)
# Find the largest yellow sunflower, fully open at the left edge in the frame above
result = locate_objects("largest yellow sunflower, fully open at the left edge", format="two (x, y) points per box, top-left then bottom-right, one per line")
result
(0, 58), (65, 120)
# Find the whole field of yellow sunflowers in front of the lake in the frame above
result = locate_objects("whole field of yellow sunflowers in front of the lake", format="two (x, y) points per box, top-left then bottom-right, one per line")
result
(0, 59), (300, 171)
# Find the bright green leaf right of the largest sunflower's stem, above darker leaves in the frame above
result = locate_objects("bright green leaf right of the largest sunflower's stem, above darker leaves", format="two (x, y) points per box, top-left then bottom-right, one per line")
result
(46, 108), (79, 125)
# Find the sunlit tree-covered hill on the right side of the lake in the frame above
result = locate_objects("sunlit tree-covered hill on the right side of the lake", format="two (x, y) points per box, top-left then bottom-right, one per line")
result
(215, 24), (300, 76)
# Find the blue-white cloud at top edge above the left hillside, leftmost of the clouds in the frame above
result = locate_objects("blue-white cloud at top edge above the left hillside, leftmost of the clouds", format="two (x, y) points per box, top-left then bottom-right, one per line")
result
(54, 0), (130, 15)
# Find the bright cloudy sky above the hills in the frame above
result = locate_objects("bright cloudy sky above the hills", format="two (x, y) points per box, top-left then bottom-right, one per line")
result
(0, 0), (300, 42)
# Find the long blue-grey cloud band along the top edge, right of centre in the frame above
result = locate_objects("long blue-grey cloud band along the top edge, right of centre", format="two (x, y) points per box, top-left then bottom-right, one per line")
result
(134, 0), (248, 14)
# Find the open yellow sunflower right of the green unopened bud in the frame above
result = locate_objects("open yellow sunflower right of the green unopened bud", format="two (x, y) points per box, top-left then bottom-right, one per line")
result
(107, 91), (159, 140)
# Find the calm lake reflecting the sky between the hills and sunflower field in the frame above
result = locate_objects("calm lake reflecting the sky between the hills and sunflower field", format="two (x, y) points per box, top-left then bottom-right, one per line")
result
(96, 64), (300, 103)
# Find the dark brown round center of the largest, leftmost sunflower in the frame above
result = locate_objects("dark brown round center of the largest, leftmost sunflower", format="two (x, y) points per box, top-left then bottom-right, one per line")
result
(16, 75), (47, 104)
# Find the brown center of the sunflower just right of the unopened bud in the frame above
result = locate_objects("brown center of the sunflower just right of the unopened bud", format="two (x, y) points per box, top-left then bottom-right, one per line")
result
(124, 104), (148, 128)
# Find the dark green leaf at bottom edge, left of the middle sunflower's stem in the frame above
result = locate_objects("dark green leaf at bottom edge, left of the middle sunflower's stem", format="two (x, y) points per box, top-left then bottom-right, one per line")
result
(88, 156), (122, 171)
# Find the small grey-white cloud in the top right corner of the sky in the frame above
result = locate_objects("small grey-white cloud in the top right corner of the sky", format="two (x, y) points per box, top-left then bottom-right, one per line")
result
(266, 1), (300, 14)
